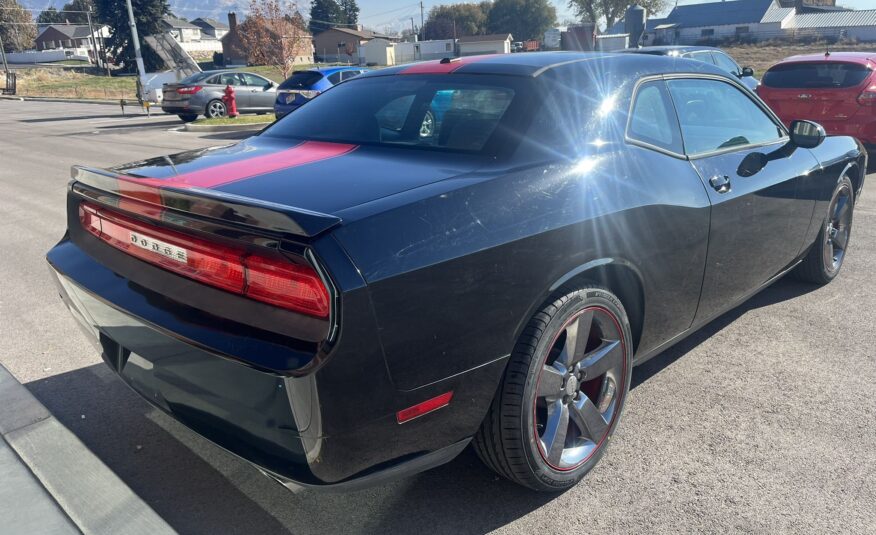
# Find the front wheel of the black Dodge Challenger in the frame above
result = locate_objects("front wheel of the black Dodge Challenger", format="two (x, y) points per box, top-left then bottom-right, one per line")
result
(792, 176), (855, 285)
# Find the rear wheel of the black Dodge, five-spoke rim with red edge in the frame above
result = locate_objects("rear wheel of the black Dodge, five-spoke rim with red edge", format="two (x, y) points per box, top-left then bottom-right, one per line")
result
(474, 286), (633, 492)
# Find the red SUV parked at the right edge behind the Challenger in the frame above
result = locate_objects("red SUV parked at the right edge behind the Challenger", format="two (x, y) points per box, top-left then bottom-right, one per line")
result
(757, 52), (876, 153)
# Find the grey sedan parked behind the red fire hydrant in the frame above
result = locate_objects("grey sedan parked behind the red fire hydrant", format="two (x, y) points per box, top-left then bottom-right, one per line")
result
(161, 71), (277, 122)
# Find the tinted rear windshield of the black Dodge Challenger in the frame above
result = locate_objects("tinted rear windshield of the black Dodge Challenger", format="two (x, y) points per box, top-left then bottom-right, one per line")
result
(262, 74), (529, 152)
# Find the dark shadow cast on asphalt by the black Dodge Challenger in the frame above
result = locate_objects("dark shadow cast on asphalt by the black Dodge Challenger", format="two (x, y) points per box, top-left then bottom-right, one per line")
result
(27, 279), (817, 534)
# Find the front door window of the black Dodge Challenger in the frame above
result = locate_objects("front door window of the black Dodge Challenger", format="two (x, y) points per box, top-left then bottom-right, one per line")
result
(666, 79), (784, 155)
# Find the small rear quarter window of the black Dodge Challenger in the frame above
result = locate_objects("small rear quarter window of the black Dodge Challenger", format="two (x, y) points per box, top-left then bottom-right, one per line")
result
(627, 80), (683, 154)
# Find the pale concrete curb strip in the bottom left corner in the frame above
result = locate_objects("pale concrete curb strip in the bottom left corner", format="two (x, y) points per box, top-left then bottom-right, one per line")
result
(0, 365), (176, 535)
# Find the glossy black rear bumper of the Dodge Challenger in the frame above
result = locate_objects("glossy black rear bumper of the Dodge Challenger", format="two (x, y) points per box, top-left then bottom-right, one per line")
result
(48, 239), (504, 490)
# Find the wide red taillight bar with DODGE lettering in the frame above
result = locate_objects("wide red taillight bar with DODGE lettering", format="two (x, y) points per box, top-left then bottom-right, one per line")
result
(79, 203), (329, 318)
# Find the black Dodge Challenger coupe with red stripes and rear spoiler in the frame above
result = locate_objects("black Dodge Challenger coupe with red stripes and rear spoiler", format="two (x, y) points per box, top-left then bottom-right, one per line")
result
(48, 53), (866, 490)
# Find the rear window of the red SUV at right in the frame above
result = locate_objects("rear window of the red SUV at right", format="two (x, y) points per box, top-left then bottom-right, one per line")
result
(761, 62), (872, 89)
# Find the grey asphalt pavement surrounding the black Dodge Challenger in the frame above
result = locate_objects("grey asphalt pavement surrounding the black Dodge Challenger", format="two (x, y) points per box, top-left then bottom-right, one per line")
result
(0, 100), (876, 534)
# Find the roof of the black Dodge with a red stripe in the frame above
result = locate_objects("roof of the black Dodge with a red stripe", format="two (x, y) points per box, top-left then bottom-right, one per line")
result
(357, 52), (727, 78)
